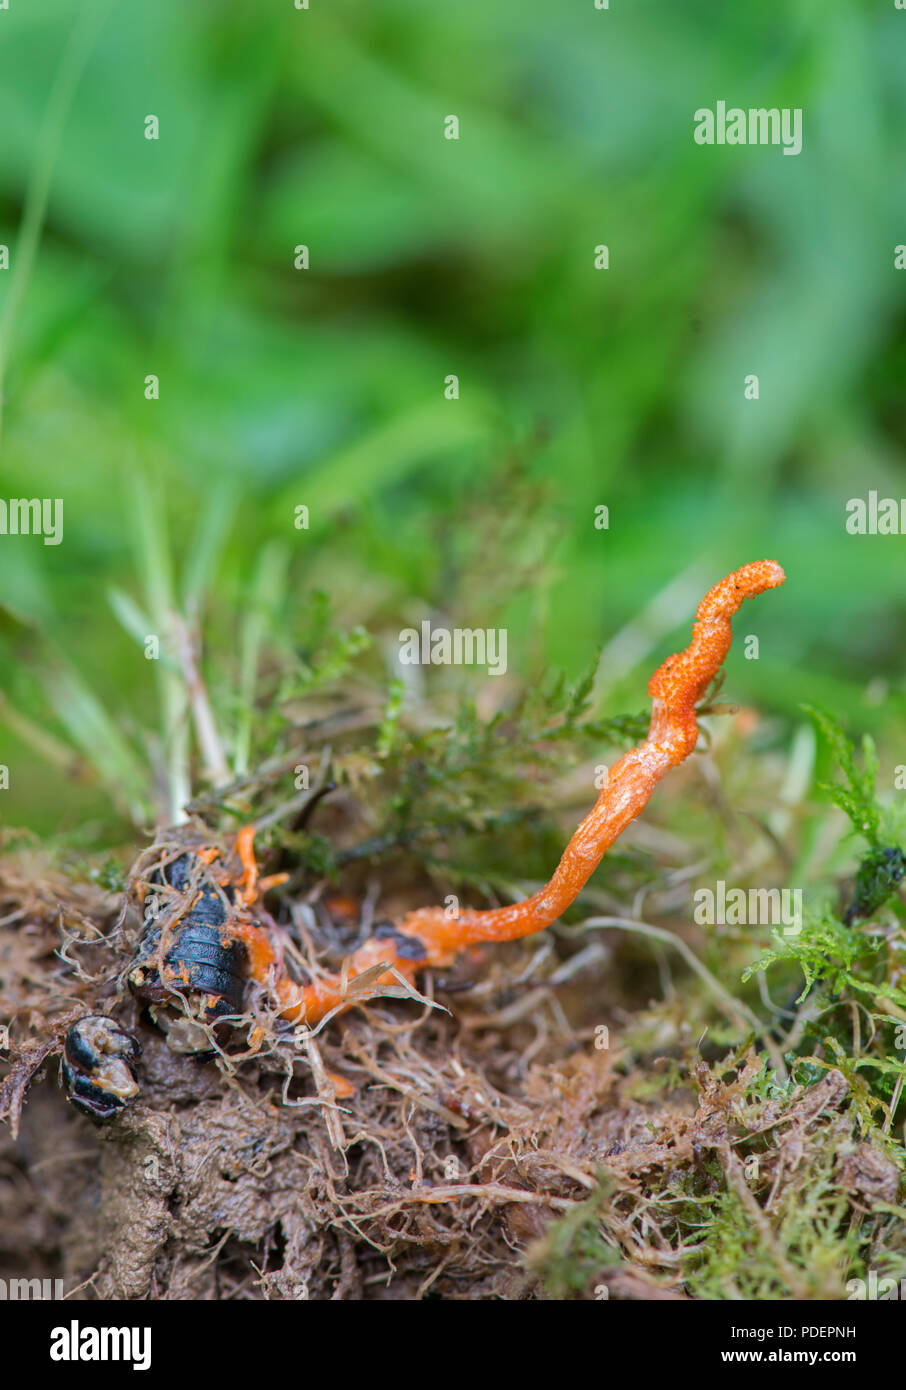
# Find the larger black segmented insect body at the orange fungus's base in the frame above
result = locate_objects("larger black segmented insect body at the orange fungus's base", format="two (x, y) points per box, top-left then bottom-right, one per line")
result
(128, 853), (246, 1052)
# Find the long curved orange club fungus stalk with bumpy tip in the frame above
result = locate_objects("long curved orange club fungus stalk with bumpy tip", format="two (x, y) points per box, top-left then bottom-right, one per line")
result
(242, 560), (785, 1024)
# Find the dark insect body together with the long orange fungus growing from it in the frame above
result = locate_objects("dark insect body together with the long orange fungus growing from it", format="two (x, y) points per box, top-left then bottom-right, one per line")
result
(63, 560), (785, 1112)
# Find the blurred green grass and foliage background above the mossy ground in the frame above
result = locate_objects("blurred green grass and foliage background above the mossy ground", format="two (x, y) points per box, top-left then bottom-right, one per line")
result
(0, 0), (906, 838)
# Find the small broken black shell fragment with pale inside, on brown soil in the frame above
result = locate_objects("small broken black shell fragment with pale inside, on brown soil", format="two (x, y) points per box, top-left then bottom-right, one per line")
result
(61, 1013), (142, 1125)
